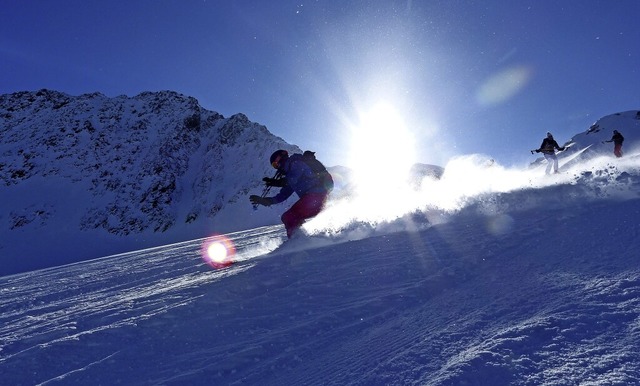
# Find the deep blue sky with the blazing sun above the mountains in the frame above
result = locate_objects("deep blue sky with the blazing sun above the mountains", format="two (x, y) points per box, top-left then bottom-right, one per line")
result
(0, 0), (640, 166)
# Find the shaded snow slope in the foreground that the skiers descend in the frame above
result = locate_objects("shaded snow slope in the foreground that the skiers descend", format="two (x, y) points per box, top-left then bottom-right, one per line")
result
(0, 152), (640, 385)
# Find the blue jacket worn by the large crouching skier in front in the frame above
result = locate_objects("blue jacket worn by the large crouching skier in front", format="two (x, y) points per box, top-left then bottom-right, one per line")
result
(271, 154), (327, 204)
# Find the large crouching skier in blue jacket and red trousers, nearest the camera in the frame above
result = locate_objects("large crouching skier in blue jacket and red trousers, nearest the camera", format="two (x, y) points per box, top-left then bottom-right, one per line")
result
(249, 150), (333, 238)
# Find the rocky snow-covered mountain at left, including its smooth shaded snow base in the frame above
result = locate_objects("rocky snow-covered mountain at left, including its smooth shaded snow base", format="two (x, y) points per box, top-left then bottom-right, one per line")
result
(0, 90), (300, 274)
